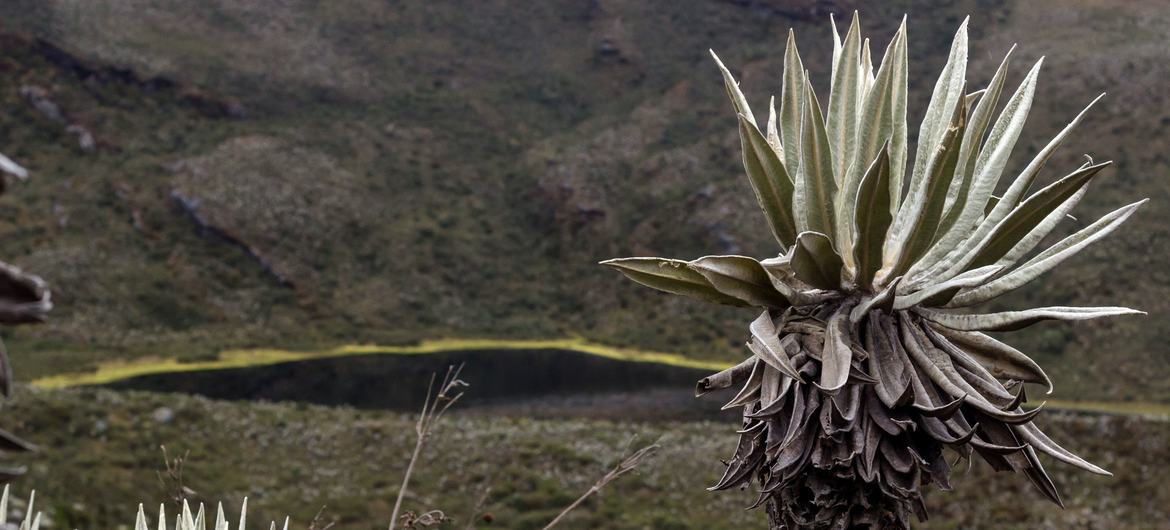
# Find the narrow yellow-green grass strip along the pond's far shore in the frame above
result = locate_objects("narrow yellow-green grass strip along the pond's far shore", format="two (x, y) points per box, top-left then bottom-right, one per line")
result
(32, 338), (1170, 420)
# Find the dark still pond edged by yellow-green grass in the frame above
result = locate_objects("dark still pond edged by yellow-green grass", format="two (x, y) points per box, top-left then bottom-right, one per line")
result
(105, 350), (737, 420)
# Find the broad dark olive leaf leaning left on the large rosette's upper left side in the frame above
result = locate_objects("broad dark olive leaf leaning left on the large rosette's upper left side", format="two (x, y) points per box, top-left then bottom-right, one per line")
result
(739, 115), (797, 246)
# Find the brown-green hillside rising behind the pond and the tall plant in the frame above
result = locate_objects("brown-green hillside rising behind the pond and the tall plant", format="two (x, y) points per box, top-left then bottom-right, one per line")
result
(0, 0), (1170, 401)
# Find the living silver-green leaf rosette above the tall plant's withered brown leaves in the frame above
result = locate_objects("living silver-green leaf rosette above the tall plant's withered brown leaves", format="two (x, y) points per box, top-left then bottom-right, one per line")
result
(604, 20), (1145, 326)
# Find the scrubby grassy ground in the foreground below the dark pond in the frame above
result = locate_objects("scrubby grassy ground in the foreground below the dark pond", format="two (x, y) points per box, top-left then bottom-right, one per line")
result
(5, 380), (1170, 530)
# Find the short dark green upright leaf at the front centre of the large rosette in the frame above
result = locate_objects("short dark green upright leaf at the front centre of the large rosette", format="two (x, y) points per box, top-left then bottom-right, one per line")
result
(853, 143), (894, 288)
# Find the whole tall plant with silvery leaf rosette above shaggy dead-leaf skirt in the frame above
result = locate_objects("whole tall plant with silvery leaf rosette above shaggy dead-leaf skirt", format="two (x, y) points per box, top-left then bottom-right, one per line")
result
(604, 15), (1144, 529)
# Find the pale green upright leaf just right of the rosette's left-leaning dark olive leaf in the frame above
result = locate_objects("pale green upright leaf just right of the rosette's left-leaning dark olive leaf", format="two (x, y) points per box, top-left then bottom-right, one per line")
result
(796, 75), (837, 234)
